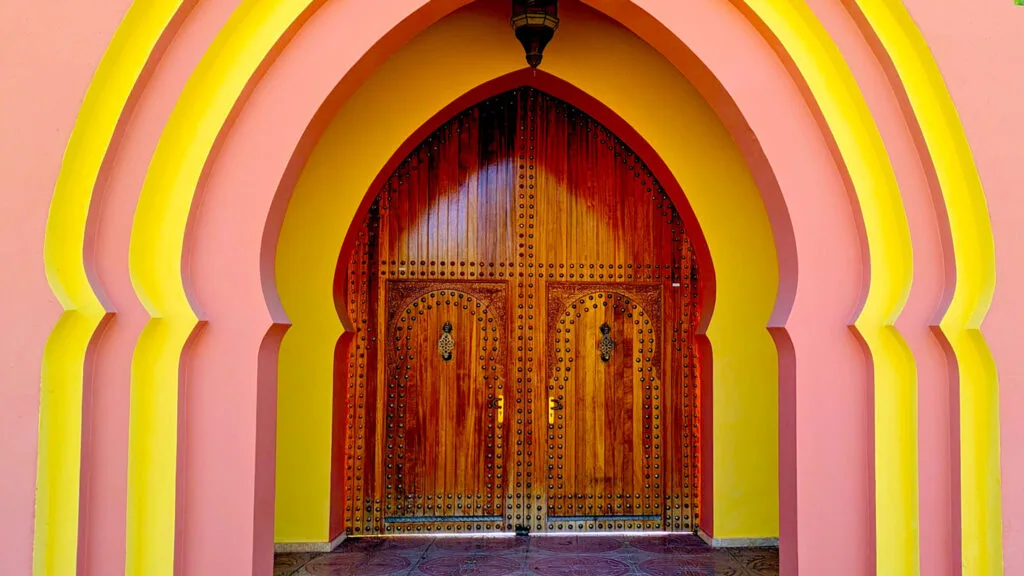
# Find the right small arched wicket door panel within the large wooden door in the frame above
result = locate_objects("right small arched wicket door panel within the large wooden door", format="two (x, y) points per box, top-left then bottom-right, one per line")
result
(547, 283), (664, 530)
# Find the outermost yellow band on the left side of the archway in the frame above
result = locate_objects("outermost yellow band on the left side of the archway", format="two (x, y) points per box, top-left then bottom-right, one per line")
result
(33, 0), (181, 575)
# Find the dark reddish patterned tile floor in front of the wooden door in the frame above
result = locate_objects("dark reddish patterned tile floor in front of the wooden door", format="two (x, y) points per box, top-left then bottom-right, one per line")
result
(273, 534), (778, 576)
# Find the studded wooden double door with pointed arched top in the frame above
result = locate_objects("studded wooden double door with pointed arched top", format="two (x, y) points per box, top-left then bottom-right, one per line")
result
(339, 88), (698, 535)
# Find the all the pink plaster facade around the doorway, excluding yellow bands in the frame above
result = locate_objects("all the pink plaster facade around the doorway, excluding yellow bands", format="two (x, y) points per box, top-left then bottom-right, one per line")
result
(0, 0), (1024, 576)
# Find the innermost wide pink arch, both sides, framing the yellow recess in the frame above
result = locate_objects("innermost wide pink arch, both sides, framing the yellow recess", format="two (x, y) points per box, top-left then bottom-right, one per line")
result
(179, 0), (873, 574)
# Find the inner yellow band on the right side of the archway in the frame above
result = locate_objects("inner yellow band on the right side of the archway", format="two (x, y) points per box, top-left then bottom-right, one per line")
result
(733, 0), (921, 574)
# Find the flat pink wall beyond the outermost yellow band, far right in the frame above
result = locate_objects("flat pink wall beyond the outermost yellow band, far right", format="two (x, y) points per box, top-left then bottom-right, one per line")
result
(906, 0), (1024, 574)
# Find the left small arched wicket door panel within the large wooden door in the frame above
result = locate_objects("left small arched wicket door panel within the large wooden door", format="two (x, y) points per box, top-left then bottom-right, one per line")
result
(384, 281), (507, 530)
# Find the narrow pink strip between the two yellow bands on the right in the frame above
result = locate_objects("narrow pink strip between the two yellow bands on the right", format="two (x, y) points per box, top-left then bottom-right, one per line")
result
(810, 0), (959, 576)
